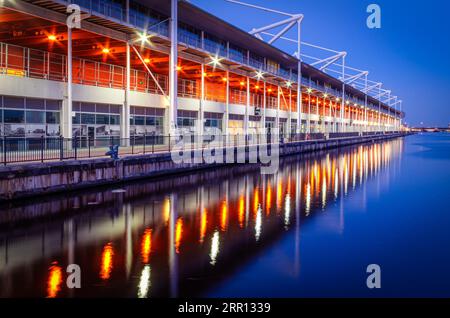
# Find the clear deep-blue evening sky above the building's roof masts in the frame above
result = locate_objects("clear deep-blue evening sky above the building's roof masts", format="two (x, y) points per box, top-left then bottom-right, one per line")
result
(191, 0), (450, 127)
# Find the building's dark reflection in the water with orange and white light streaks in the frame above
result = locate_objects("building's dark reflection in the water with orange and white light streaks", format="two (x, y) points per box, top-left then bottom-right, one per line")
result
(0, 139), (403, 297)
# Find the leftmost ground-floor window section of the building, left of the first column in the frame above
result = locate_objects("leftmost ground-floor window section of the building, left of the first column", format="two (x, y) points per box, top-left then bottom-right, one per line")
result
(0, 96), (62, 138)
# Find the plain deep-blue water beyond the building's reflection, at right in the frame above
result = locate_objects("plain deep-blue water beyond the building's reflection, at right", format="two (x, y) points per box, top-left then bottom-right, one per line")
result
(209, 134), (450, 297)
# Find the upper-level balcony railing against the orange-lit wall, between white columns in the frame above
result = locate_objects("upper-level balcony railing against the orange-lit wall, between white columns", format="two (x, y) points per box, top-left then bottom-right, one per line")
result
(0, 42), (400, 118)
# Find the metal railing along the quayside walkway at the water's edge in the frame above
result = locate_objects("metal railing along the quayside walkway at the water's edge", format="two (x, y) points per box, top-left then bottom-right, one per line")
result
(0, 131), (401, 165)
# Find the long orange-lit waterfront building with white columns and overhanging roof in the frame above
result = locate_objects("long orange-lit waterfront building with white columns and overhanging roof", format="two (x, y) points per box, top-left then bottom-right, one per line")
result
(0, 0), (404, 139)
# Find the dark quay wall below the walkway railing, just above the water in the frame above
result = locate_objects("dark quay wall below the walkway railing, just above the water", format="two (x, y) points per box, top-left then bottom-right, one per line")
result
(0, 134), (403, 201)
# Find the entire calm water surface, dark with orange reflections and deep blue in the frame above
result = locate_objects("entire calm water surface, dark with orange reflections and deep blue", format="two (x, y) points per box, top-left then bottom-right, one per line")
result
(0, 134), (450, 297)
